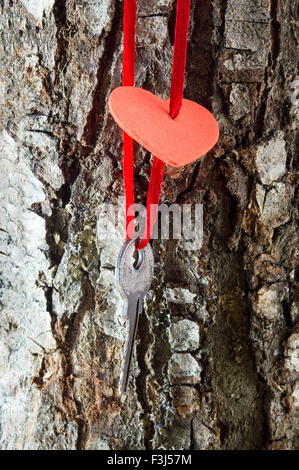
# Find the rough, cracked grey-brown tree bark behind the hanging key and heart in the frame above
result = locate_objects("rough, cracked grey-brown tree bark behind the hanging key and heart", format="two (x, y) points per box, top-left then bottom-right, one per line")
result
(0, 0), (299, 450)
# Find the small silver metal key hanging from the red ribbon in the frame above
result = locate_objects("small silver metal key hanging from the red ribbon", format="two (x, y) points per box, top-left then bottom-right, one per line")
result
(116, 239), (154, 395)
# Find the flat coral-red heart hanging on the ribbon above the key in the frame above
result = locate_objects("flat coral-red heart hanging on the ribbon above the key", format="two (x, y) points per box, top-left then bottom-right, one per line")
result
(108, 86), (219, 167)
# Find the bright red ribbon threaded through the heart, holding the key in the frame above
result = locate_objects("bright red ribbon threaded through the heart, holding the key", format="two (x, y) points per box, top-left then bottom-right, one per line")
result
(123, 0), (190, 250)
